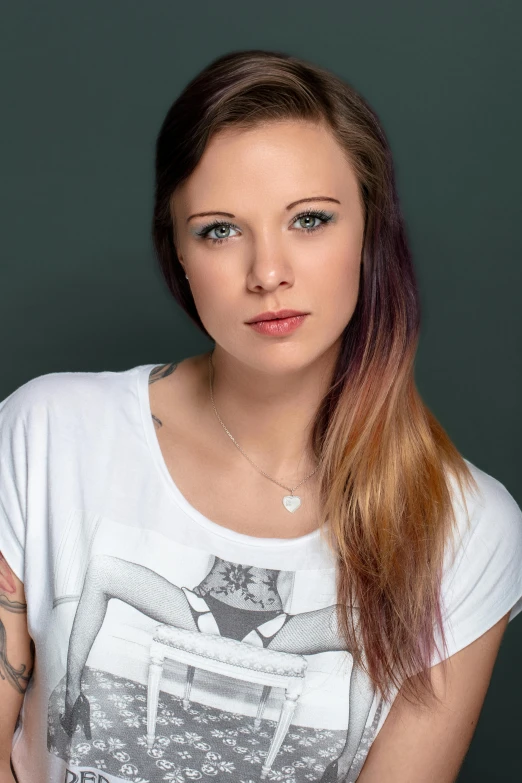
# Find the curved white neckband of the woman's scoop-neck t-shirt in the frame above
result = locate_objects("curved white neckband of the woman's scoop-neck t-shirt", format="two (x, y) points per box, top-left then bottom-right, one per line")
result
(137, 362), (321, 548)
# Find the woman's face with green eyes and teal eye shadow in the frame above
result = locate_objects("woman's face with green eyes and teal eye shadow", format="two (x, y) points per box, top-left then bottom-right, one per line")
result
(171, 120), (364, 374)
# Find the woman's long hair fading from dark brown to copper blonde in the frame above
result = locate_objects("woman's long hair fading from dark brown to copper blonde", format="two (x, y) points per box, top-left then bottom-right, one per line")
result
(153, 49), (476, 704)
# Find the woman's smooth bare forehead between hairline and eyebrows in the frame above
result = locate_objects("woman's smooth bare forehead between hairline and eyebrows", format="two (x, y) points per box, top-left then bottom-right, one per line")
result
(172, 120), (358, 213)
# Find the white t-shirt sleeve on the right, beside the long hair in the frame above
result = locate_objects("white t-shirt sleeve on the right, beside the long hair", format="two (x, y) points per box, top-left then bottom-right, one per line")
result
(434, 460), (522, 663)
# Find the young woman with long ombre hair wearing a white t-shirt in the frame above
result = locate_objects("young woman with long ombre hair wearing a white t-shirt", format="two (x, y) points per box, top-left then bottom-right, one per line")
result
(0, 50), (522, 783)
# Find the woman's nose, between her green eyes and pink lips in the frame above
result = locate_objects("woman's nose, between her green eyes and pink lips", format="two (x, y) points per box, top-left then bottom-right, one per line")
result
(247, 233), (294, 291)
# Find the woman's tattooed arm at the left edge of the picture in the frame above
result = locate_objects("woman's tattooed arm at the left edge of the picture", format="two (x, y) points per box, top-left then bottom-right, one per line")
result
(0, 552), (34, 783)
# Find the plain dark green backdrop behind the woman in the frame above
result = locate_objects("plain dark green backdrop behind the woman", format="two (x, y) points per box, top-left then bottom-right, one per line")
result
(0, 0), (522, 783)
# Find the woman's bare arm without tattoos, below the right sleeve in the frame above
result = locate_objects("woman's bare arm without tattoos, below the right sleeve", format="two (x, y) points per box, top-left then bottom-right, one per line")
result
(357, 612), (509, 783)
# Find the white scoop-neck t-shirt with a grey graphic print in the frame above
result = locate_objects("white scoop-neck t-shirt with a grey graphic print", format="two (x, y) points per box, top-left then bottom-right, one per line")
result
(0, 364), (522, 783)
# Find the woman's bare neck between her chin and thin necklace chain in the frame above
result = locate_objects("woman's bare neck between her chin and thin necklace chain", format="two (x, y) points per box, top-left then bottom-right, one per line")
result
(197, 344), (338, 481)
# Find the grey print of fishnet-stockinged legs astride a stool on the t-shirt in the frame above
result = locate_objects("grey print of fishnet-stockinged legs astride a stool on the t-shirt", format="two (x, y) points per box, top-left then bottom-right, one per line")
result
(48, 528), (381, 783)
